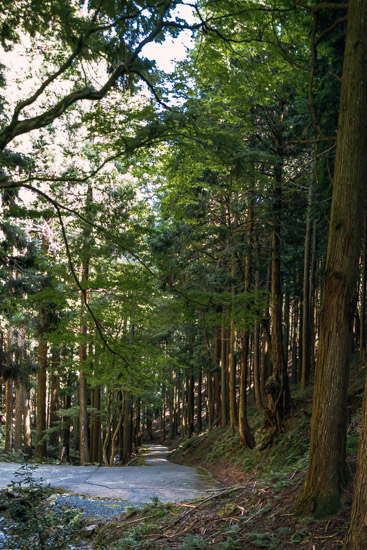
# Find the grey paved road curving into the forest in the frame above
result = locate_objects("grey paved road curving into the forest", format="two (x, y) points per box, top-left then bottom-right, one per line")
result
(0, 445), (217, 504)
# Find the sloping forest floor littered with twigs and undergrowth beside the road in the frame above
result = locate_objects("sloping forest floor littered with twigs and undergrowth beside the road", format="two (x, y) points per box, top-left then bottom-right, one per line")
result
(87, 362), (366, 550)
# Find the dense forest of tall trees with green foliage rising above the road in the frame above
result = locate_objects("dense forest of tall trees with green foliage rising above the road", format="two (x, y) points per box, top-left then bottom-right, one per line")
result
(0, 0), (367, 549)
